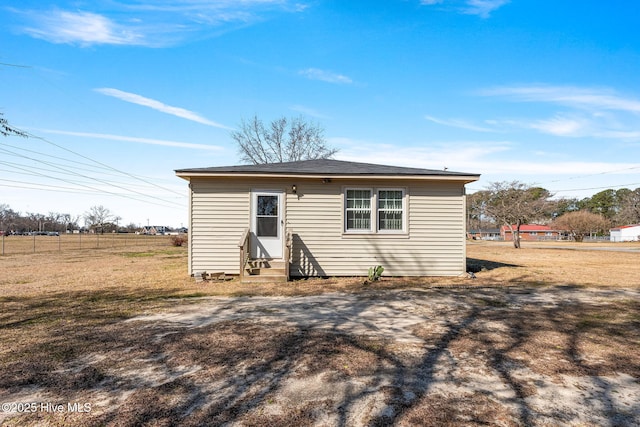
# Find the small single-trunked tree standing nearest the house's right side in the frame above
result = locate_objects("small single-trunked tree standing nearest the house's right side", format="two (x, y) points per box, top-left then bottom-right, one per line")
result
(485, 181), (551, 249)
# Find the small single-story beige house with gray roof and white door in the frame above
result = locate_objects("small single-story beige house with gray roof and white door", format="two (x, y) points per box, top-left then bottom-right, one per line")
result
(176, 159), (480, 279)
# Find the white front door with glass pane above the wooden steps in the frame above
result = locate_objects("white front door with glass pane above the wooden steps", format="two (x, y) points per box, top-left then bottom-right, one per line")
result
(251, 190), (284, 259)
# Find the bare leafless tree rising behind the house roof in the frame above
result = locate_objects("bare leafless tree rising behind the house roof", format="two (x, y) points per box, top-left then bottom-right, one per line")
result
(231, 116), (338, 165)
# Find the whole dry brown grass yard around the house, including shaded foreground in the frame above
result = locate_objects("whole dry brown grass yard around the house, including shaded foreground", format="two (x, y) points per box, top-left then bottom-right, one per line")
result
(0, 242), (640, 426)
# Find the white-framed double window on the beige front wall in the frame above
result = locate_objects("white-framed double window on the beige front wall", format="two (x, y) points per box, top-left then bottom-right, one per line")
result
(344, 188), (406, 233)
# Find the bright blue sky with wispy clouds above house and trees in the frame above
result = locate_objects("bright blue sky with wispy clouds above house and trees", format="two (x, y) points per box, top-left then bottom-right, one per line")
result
(0, 0), (640, 226)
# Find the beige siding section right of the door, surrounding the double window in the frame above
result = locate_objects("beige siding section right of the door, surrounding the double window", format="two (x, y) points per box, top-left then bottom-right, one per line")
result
(287, 181), (465, 276)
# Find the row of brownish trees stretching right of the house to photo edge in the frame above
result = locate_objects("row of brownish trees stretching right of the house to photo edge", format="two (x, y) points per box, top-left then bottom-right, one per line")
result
(467, 181), (640, 248)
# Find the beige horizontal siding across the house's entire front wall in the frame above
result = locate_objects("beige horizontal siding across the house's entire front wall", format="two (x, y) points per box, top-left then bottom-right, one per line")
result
(191, 178), (465, 276)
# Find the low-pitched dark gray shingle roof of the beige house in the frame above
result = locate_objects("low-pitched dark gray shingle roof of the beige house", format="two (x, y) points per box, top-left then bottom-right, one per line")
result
(176, 159), (480, 177)
